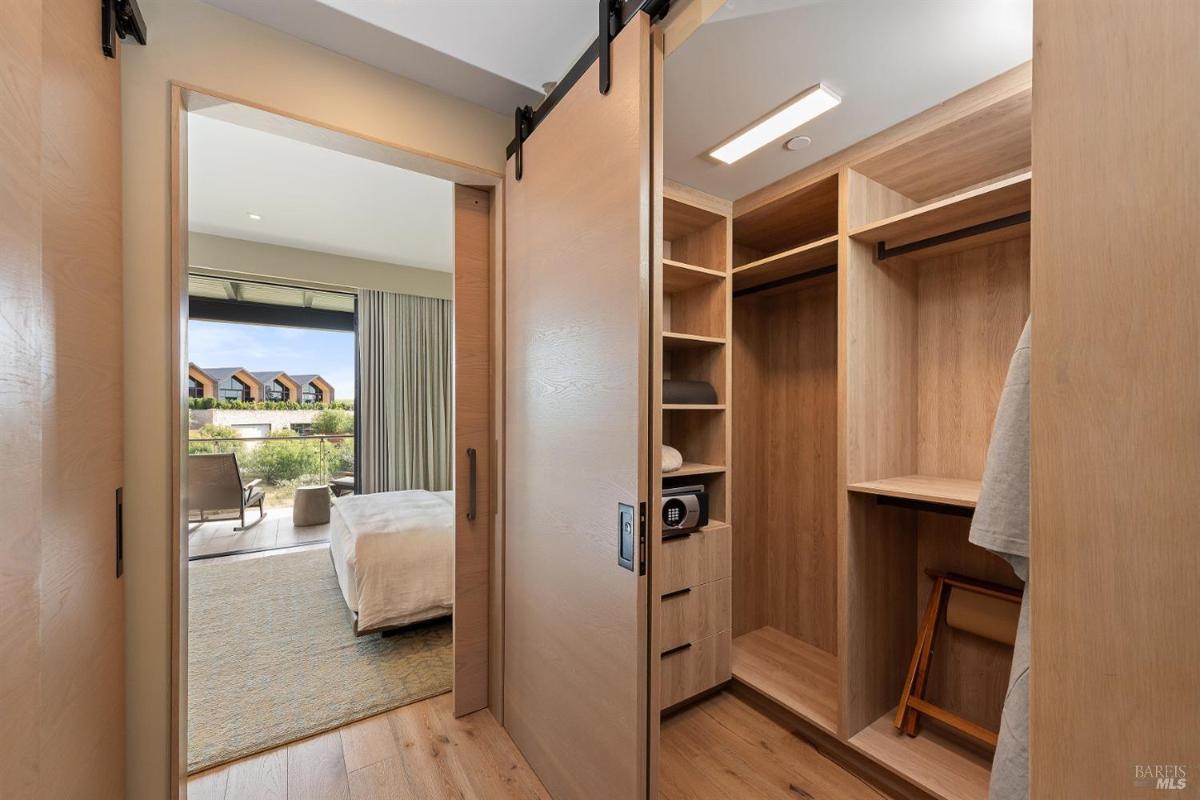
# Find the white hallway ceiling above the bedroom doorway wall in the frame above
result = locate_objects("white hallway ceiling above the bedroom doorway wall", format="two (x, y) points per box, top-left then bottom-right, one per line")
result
(205, 0), (598, 114)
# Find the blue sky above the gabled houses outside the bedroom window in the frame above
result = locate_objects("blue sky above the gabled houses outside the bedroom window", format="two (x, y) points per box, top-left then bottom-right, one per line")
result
(187, 320), (354, 399)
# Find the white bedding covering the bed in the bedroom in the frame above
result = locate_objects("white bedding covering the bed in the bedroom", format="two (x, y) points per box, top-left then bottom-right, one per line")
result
(329, 491), (454, 632)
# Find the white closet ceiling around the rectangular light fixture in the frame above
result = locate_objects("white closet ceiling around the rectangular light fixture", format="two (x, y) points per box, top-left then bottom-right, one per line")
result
(664, 0), (1033, 199)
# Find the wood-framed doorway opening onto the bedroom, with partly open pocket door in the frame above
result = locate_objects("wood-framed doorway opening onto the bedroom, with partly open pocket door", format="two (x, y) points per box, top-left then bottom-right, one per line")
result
(173, 86), (497, 781)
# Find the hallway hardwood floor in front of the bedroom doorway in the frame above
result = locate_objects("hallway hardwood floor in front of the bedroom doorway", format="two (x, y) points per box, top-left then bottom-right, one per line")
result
(187, 694), (550, 800)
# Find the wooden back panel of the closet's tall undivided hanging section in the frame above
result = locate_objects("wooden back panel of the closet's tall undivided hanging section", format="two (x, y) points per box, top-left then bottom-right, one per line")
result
(730, 281), (838, 652)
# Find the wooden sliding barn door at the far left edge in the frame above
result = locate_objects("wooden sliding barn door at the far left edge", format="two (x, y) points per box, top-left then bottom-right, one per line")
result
(0, 0), (123, 800)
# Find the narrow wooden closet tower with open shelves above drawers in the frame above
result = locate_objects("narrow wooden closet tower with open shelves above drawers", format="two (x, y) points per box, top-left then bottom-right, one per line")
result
(652, 185), (732, 709)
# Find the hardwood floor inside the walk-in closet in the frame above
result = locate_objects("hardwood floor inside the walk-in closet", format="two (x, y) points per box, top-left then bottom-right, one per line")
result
(659, 692), (886, 800)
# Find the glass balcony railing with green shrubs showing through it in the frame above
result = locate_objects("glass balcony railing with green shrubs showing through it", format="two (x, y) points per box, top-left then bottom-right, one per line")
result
(187, 433), (354, 506)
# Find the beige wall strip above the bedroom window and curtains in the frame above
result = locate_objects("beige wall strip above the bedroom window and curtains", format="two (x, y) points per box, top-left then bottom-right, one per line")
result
(187, 233), (454, 300)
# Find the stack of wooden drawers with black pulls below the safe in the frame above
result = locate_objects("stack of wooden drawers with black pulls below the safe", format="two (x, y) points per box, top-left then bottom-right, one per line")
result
(659, 522), (732, 708)
